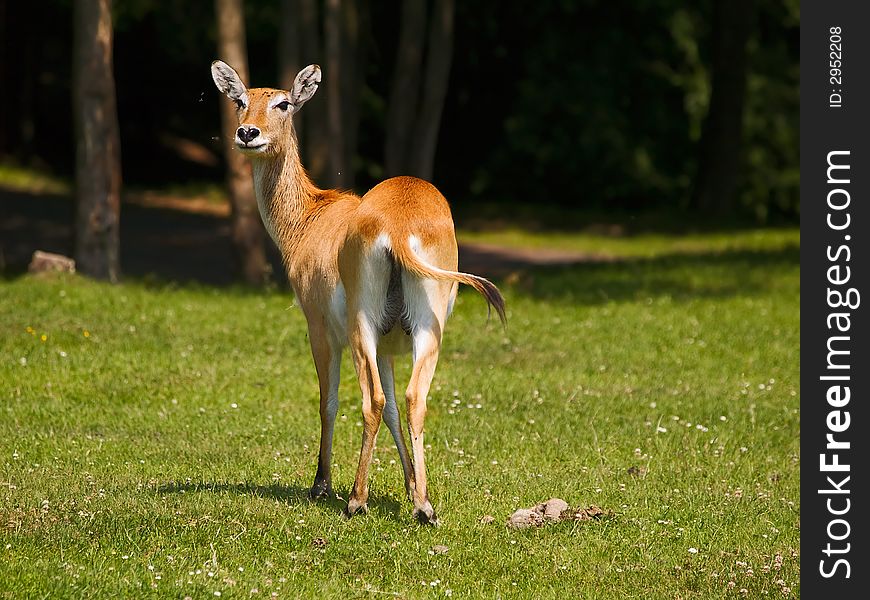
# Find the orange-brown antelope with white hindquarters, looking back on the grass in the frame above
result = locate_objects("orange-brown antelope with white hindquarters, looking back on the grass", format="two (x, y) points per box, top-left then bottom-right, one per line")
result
(211, 61), (506, 525)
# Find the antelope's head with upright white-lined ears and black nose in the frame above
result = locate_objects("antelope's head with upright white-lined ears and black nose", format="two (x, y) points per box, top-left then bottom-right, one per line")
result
(211, 60), (320, 157)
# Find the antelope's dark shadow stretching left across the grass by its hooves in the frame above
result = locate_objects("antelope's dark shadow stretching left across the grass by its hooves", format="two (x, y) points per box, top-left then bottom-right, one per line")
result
(157, 481), (401, 521)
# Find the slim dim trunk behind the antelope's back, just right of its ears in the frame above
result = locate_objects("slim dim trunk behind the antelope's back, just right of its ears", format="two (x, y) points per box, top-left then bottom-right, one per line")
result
(324, 0), (348, 187)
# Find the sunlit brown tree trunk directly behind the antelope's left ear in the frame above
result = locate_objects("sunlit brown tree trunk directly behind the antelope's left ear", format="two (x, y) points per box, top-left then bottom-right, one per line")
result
(215, 0), (268, 285)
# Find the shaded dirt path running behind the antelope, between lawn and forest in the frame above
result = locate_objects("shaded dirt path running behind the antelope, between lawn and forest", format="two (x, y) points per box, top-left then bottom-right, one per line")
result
(0, 189), (591, 285)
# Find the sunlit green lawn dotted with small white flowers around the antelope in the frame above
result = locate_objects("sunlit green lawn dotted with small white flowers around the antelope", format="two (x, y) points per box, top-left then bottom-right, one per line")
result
(0, 229), (800, 599)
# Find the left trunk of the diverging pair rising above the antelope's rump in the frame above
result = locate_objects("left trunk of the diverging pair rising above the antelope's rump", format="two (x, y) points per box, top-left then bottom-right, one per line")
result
(384, 0), (426, 176)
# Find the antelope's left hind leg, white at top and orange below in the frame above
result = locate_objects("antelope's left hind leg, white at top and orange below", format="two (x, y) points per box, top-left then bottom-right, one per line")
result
(345, 320), (386, 517)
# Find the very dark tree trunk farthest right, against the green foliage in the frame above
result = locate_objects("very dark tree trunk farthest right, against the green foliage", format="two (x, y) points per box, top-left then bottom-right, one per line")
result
(693, 0), (755, 215)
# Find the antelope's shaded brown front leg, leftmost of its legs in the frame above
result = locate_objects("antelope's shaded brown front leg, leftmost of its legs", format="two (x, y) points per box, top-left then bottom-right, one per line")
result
(308, 327), (341, 500)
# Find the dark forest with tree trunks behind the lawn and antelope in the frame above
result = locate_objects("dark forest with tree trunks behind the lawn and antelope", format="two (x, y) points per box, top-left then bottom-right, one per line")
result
(0, 0), (800, 284)
